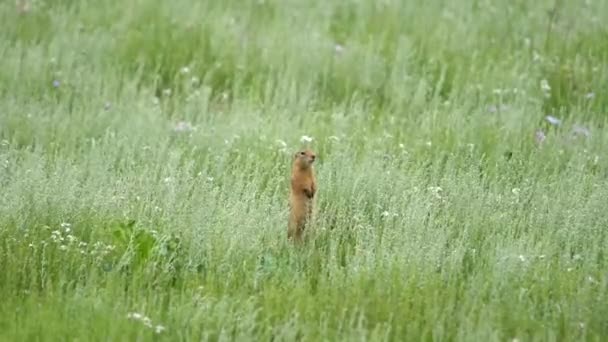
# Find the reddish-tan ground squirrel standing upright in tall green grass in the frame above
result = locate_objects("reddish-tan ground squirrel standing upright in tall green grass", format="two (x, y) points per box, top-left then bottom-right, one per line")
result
(287, 149), (317, 242)
